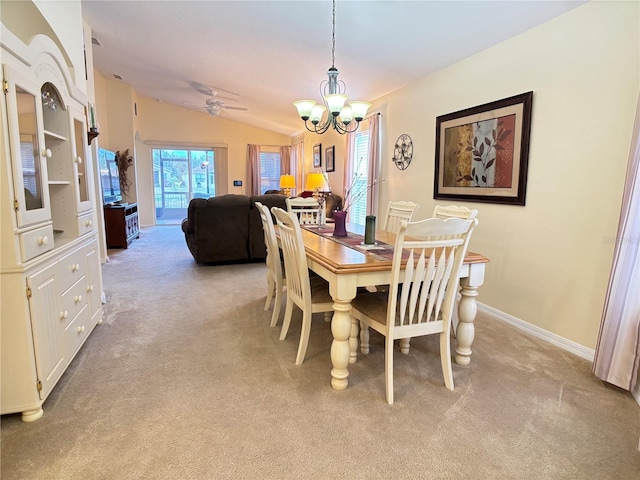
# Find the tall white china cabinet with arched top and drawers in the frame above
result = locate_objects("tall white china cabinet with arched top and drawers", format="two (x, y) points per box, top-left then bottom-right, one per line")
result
(0, 31), (102, 421)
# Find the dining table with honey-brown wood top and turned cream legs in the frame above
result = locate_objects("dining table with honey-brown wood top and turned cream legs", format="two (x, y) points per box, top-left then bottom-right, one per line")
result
(276, 220), (489, 390)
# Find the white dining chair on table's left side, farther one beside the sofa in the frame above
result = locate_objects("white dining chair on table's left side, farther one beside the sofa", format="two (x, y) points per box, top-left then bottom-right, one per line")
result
(255, 202), (286, 327)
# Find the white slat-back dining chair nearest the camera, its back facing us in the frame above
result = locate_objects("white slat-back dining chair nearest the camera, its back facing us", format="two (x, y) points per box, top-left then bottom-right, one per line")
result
(351, 218), (477, 404)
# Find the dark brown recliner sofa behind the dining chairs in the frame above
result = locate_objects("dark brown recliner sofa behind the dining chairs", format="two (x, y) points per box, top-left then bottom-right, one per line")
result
(182, 194), (287, 263)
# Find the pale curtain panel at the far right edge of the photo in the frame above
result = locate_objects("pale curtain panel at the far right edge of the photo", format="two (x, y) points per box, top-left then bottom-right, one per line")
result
(593, 98), (640, 391)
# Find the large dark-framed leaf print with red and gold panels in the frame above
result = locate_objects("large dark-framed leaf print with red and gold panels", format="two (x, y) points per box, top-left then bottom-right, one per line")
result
(433, 92), (533, 205)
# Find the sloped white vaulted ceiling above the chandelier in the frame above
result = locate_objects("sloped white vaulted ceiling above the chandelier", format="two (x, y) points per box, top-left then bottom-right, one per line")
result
(82, 0), (585, 135)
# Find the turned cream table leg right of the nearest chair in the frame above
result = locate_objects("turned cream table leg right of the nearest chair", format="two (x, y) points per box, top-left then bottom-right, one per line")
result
(455, 264), (484, 365)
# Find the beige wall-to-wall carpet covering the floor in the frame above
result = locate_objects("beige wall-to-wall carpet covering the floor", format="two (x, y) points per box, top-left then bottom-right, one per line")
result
(1, 226), (640, 480)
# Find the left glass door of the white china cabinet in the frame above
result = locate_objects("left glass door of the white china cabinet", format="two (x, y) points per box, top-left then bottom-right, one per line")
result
(5, 66), (51, 226)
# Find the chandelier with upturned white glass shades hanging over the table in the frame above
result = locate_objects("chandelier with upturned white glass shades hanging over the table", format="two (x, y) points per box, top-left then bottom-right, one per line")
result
(293, 0), (371, 134)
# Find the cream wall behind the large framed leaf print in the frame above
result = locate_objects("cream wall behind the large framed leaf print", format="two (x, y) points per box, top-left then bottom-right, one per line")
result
(372, 2), (640, 349)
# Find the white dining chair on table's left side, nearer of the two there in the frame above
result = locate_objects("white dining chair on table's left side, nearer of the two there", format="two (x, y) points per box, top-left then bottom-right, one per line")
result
(271, 207), (333, 365)
